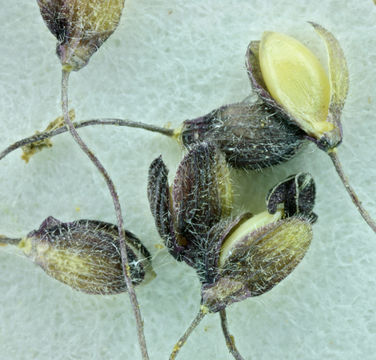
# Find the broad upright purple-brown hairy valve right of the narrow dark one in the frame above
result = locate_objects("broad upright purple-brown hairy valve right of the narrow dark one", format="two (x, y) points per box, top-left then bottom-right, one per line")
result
(172, 143), (232, 237)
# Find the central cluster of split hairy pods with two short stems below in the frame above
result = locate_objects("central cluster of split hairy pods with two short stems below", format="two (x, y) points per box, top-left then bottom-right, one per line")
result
(148, 143), (317, 360)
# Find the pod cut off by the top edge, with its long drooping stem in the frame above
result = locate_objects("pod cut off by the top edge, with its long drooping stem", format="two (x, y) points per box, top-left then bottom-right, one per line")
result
(38, 0), (149, 360)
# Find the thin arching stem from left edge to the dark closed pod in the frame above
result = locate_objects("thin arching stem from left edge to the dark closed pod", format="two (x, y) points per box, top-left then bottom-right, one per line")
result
(0, 119), (174, 160)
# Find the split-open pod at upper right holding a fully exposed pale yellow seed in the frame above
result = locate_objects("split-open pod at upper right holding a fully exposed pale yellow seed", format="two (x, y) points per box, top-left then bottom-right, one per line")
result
(246, 23), (349, 151)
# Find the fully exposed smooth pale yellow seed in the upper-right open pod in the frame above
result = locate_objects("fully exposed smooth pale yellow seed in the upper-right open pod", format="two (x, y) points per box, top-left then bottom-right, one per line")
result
(259, 32), (333, 138)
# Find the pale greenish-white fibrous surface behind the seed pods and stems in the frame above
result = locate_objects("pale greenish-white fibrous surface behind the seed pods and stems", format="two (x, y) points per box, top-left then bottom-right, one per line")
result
(0, 0), (376, 360)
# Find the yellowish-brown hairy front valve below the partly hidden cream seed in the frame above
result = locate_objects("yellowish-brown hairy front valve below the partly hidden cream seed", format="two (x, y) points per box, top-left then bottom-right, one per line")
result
(202, 217), (312, 312)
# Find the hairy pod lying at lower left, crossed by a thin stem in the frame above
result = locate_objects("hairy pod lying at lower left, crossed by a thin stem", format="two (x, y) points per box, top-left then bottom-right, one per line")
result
(19, 216), (155, 295)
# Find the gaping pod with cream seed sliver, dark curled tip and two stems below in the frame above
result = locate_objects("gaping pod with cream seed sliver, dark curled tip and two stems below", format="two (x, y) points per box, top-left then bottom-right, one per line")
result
(170, 173), (317, 359)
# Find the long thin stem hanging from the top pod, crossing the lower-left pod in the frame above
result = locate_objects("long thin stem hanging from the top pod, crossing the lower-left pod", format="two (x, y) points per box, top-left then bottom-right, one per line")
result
(61, 69), (149, 360)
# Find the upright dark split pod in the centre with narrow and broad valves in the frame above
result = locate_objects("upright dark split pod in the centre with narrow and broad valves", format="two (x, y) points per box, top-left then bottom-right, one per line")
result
(148, 143), (232, 267)
